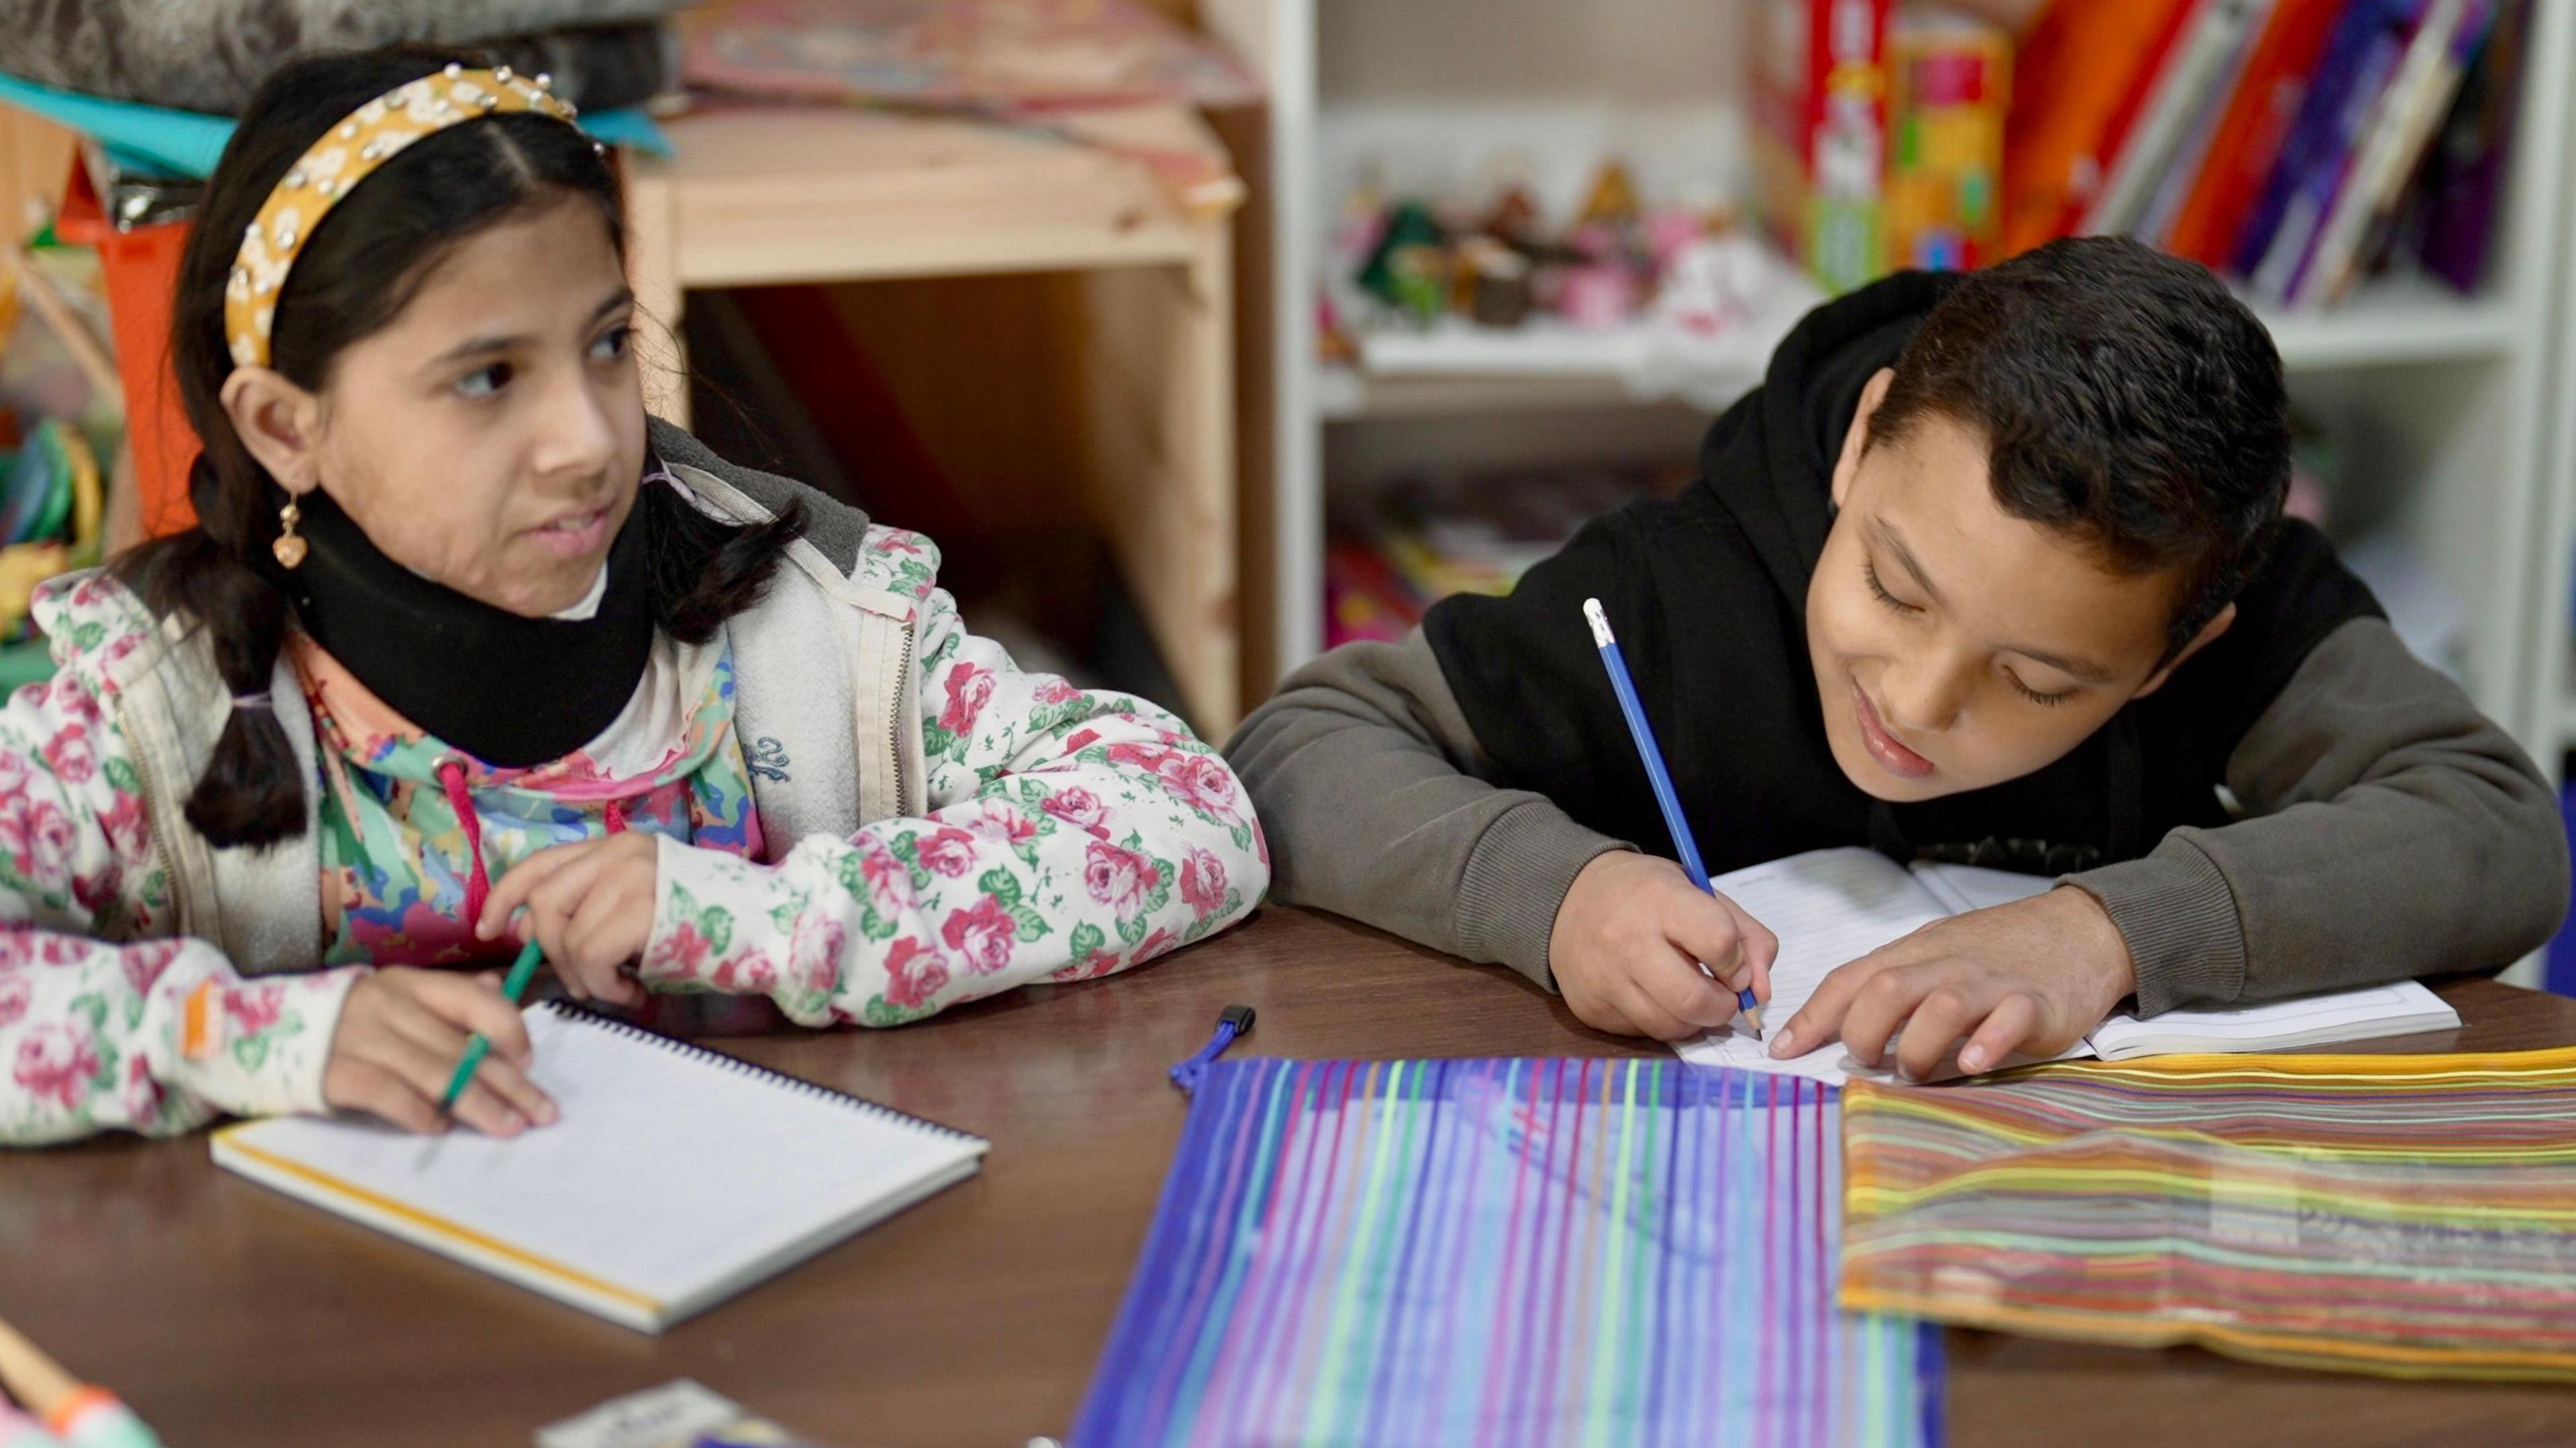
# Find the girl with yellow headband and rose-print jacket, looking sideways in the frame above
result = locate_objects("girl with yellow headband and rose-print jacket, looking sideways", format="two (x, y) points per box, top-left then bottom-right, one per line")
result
(0, 52), (1270, 1144)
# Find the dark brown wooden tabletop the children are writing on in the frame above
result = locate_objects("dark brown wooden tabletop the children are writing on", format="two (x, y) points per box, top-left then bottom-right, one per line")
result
(0, 909), (2576, 1448)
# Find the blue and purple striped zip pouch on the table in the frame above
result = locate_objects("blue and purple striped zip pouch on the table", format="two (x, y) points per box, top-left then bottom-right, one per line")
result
(1071, 1059), (1940, 1448)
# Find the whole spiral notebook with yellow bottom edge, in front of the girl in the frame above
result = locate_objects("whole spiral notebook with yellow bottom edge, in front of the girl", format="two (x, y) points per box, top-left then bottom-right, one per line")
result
(214, 1002), (989, 1332)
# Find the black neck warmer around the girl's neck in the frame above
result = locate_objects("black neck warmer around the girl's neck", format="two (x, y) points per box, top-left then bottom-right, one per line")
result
(270, 484), (654, 768)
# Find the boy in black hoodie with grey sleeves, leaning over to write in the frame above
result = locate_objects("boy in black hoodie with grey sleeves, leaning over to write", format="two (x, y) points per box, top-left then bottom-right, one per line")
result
(1229, 239), (2568, 1074)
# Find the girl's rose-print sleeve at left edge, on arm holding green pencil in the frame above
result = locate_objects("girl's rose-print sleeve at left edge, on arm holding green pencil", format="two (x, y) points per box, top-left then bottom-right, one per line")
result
(0, 582), (356, 1144)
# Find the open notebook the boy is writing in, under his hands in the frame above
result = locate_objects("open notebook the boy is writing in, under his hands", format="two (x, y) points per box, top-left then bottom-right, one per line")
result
(1677, 850), (2460, 1082)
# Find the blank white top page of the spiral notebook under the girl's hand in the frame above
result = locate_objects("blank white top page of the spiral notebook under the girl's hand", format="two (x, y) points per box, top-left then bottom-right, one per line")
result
(221, 1005), (984, 1301)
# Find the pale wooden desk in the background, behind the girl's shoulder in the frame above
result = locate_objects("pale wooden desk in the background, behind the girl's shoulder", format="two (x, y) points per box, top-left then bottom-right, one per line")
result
(626, 106), (1244, 740)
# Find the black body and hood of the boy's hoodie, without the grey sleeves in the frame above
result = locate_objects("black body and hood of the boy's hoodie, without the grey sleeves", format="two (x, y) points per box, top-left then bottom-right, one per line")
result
(1425, 273), (2377, 873)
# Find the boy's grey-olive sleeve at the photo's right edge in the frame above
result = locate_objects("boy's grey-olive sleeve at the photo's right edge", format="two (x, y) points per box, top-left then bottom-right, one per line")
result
(2066, 618), (2568, 1015)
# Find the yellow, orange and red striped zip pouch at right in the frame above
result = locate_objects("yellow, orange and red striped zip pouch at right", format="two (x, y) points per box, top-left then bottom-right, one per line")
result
(1842, 1049), (2576, 1381)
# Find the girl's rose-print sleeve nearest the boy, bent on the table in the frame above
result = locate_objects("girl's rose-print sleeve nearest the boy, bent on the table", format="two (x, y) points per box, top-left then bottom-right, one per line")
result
(641, 528), (1270, 1025)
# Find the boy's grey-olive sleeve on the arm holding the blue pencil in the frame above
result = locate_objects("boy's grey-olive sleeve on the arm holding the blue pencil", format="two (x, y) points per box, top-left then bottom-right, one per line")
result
(1226, 628), (1633, 989)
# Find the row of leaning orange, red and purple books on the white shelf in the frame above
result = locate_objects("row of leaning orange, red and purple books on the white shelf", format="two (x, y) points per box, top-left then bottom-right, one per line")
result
(2004, 0), (2530, 307)
